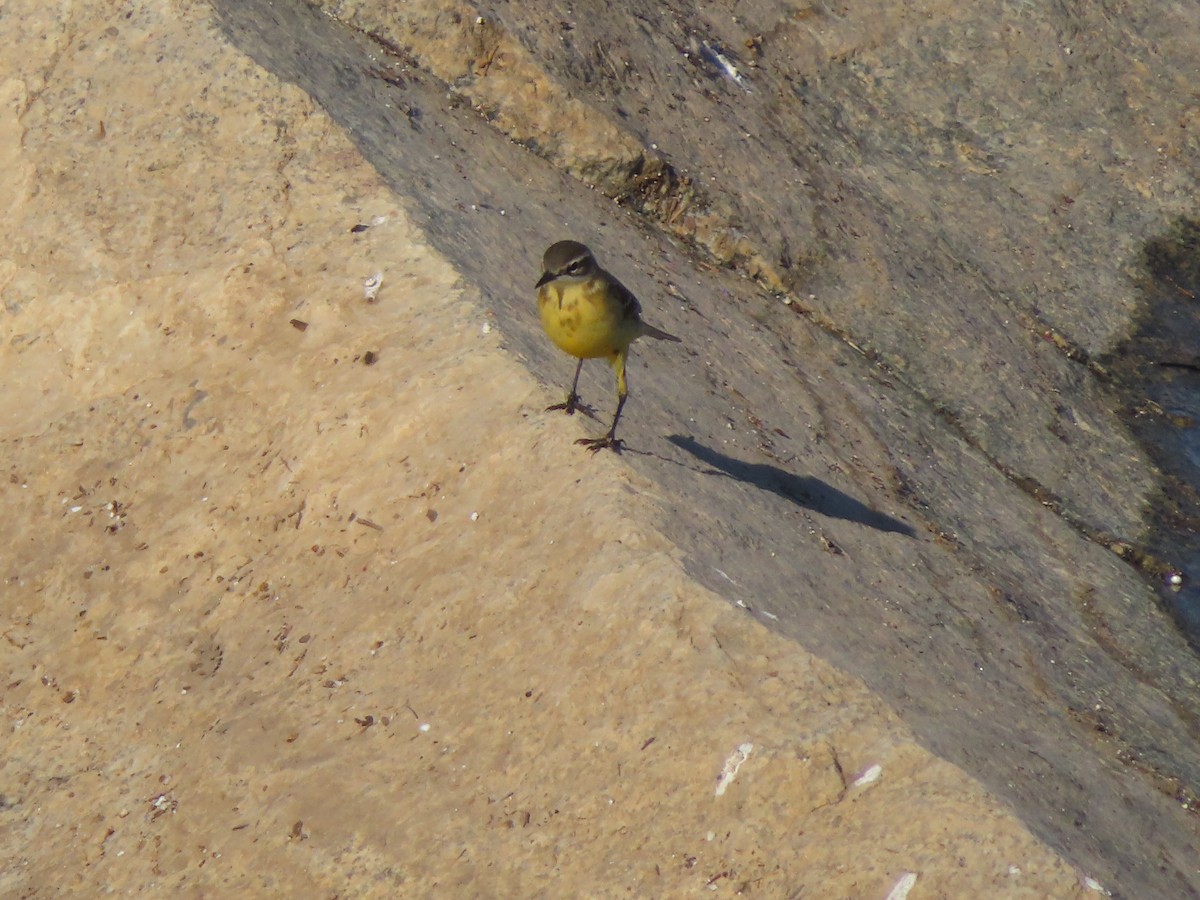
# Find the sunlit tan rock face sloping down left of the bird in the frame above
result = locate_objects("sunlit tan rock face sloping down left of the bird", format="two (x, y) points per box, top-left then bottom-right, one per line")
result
(0, 4), (1099, 896)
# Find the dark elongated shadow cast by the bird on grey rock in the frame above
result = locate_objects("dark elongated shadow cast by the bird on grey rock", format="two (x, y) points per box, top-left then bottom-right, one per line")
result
(667, 434), (916, 538)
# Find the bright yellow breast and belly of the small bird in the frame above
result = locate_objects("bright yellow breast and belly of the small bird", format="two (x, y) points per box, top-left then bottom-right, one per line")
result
(538, 278), (638, 359)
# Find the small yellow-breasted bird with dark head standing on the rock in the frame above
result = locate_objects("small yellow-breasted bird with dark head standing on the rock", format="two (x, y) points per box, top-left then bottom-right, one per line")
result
(538, 241), (679, 452)
